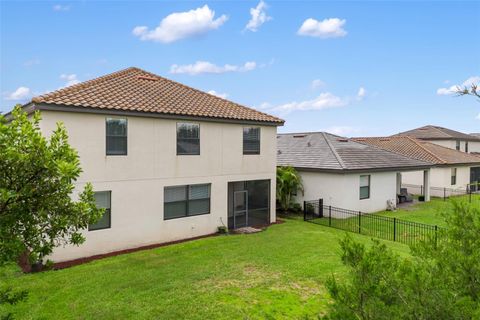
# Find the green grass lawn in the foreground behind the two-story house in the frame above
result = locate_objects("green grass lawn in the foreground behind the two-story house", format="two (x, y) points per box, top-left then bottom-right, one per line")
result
(0, 219), (409, 319)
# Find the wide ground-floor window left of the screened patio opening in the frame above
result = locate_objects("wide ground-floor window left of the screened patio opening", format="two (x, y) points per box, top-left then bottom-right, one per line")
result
(163, 184), (210, 220)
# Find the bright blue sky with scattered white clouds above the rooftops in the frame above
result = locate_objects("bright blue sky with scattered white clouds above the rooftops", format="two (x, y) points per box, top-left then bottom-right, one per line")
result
(0, 0), (480, 136)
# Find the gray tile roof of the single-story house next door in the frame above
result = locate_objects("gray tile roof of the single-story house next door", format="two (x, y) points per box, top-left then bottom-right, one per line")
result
(277, 132), (431, 171)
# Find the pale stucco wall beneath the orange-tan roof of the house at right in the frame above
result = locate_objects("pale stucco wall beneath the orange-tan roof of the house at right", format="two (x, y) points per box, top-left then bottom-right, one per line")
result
(402, 166), (470, 197)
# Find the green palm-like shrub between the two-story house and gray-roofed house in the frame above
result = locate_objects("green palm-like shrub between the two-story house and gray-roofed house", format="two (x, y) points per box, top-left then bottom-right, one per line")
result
(277, 166), (303, 212)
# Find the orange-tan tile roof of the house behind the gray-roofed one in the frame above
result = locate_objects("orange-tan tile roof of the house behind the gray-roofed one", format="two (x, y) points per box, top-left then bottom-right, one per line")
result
(353, 136), (480, 165)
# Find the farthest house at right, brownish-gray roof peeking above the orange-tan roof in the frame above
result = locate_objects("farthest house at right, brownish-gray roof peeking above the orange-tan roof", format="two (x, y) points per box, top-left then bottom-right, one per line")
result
(394, 125), (480, 152)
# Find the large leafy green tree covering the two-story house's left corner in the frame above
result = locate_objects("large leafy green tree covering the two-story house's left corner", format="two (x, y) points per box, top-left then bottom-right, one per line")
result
(0, 106), (103, 318)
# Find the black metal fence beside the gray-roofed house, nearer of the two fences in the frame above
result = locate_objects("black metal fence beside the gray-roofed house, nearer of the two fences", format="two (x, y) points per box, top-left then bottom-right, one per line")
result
(303, 199), (441, 245)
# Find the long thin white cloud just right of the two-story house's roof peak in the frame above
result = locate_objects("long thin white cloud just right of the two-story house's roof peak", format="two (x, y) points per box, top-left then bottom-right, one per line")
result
(170, 61), (257, 75)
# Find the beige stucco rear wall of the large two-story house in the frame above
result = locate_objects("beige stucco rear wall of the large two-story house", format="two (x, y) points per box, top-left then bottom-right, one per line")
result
(41, 111), (276, 261)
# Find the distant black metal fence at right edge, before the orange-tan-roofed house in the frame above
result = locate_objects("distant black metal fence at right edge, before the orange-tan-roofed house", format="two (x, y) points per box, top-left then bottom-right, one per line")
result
(402, 184), (480, 203)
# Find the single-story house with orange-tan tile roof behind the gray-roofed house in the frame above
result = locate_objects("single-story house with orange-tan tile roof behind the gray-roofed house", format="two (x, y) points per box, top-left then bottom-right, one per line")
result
(354, 136), (480, 197)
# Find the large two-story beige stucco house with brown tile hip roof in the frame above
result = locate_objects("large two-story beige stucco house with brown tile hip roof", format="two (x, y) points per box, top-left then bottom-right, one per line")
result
(15, 68), (283, 261)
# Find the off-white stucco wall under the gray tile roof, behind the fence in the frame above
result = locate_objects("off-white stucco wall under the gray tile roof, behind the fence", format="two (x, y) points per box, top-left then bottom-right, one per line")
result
(296, 171), (397, 213)
